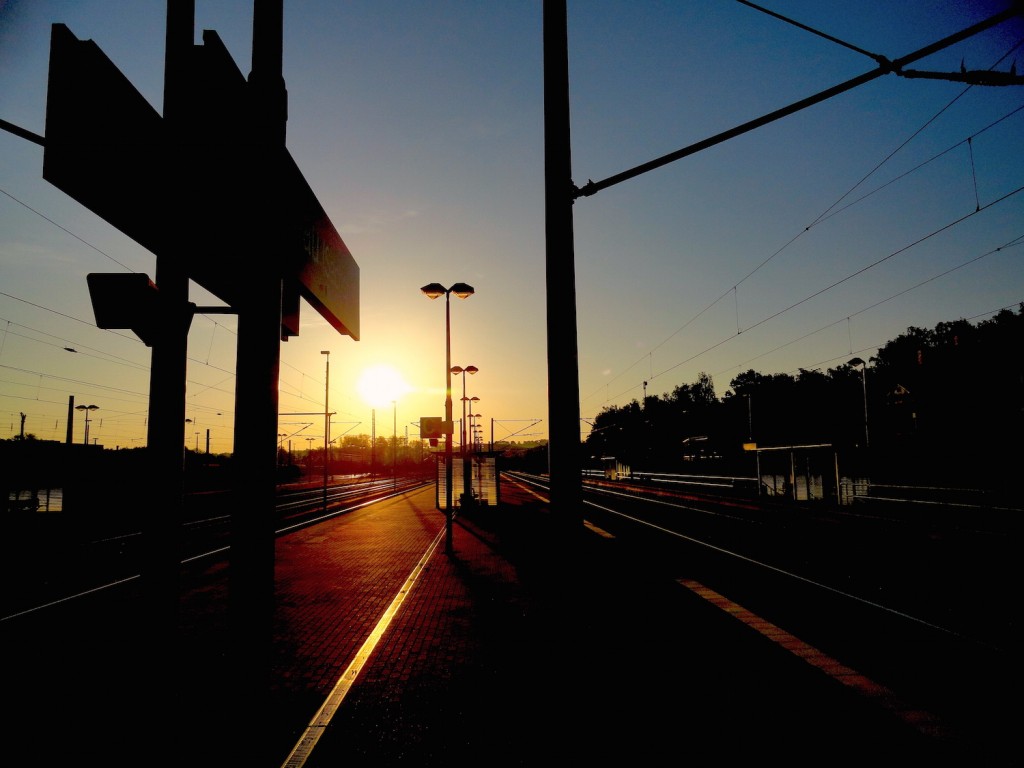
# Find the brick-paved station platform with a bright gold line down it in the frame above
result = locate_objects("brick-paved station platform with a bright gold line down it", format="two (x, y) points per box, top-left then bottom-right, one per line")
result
(6, 481), (983, 768)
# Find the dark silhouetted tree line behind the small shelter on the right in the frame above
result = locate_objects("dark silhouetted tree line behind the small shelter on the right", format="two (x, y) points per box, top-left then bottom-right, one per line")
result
(584, 303), (1024, 488)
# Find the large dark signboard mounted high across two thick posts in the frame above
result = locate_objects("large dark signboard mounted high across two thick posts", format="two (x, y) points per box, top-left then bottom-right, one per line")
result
(43, 24), (359, 339)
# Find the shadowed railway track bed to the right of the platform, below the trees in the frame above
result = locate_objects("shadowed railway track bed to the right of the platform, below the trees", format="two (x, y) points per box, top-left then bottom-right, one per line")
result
(506, 473), (1022, 753)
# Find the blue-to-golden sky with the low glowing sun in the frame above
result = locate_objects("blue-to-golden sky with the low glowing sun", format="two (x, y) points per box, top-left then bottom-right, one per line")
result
(0, 0), (1024, 453)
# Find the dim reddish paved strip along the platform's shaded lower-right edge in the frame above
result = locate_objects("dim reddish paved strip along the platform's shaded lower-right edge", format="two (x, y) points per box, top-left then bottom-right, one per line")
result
(676, 579), (947, 736)
